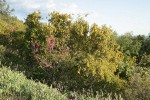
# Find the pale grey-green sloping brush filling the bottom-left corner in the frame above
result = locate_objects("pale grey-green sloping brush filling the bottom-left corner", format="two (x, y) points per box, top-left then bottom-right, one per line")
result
(0, 67), (67, 100)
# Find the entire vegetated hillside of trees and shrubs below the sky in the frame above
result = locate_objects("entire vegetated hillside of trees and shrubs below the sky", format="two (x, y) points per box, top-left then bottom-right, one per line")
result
(0, 0), (150, 100)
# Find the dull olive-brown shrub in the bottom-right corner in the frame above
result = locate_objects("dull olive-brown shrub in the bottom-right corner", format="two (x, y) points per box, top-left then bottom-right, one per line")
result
(125, 68), (150, 100)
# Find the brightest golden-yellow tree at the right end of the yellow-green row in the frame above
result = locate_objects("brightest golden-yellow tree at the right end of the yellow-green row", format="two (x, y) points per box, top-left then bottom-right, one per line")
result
(88, 24), (123, 80)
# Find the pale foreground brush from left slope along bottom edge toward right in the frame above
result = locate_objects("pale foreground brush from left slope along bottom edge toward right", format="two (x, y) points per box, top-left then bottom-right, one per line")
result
(0, 65), (123, 100)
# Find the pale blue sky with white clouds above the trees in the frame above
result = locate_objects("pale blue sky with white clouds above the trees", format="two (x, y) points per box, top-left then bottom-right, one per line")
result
(7, 0), (150, 35)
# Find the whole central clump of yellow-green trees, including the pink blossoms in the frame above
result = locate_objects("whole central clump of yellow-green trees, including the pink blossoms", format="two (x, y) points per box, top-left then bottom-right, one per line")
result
(21, 12), (126, 91)
